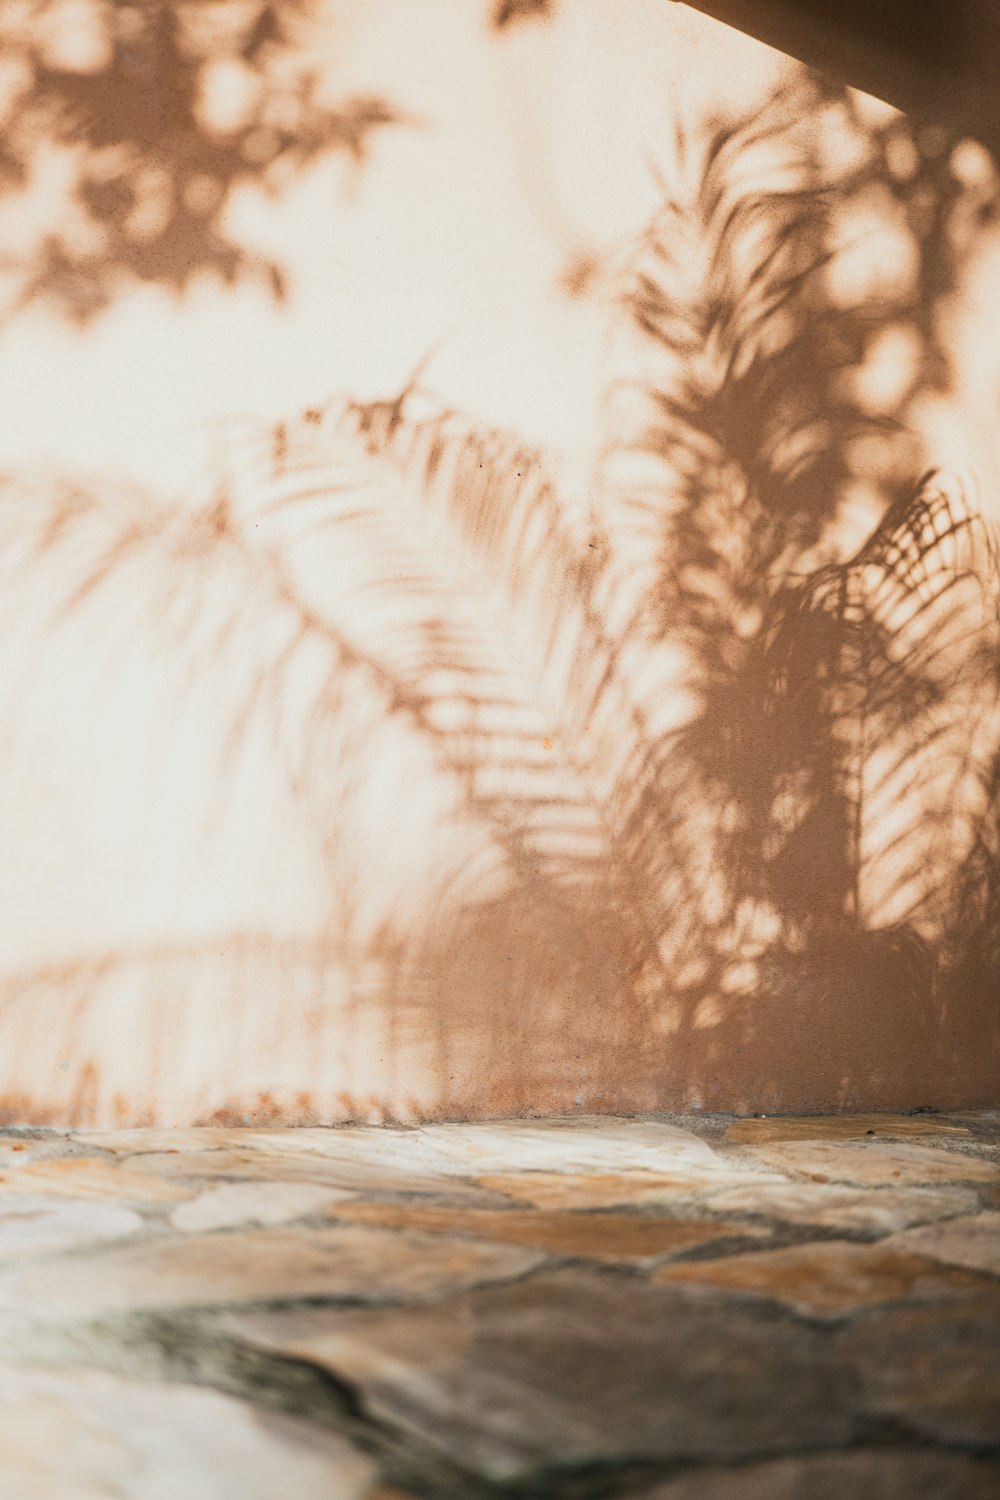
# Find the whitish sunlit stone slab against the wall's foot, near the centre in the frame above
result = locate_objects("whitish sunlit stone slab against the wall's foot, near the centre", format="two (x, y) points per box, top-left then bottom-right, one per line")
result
(417, 1119), (732, 1178)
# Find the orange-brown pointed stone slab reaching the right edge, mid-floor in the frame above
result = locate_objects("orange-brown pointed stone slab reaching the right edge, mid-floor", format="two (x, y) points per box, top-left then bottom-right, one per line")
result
(654, 1239), (982, 1317)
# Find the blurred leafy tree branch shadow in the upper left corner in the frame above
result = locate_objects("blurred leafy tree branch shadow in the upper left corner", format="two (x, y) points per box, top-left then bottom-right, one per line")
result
(0, 0), (415, 324)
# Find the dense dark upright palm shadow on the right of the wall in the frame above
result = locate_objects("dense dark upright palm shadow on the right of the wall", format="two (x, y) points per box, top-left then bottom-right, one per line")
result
(604, 81), (999, 1107)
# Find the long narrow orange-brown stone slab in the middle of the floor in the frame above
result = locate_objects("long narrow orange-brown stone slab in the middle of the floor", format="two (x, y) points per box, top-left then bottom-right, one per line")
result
(333, 1203), (768, 1262)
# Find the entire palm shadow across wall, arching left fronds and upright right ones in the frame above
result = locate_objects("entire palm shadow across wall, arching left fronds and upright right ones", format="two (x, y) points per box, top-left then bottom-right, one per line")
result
(0, 81), (1000, 1121)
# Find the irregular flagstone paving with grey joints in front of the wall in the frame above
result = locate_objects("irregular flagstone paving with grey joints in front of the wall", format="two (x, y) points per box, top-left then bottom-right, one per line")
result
(0, 1112), (1000, 1500)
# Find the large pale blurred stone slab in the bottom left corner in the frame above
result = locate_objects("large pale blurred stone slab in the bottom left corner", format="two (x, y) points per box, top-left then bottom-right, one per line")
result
(0, 1368), (373, 1500)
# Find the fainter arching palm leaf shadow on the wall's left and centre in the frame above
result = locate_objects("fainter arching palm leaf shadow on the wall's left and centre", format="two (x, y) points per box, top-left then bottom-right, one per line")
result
(6, 381), (653, 1112)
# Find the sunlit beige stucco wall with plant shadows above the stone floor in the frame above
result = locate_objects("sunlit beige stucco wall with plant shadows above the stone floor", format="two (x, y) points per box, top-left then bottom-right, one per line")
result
(0, 0), (1000, 1124)
